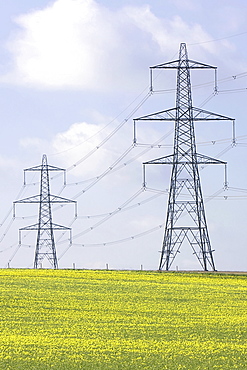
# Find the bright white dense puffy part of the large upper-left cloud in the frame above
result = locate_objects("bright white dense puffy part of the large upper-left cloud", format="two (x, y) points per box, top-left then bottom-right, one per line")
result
(5, 0), (117, 88)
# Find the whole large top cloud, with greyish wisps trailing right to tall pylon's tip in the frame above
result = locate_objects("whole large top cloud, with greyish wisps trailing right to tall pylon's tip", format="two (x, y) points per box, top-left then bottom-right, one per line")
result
(1, 0), (228, 91)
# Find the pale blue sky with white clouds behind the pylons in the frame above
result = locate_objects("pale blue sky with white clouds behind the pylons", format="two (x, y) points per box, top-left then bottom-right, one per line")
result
(0, 0), (247, 271)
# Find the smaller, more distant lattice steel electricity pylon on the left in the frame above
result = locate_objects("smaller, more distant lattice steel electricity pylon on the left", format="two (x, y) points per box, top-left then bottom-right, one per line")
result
(14, 154), (76, 269)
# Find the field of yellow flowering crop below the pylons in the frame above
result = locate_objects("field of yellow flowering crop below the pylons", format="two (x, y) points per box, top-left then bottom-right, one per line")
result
(0, 269), (247, 370)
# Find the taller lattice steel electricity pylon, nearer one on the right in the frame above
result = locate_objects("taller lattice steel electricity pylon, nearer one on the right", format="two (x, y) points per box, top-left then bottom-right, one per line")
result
(134, 43), (234, 271)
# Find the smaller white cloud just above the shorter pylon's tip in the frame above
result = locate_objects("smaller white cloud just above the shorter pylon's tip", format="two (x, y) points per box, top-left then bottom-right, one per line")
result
(17, 122), (112, 177)
